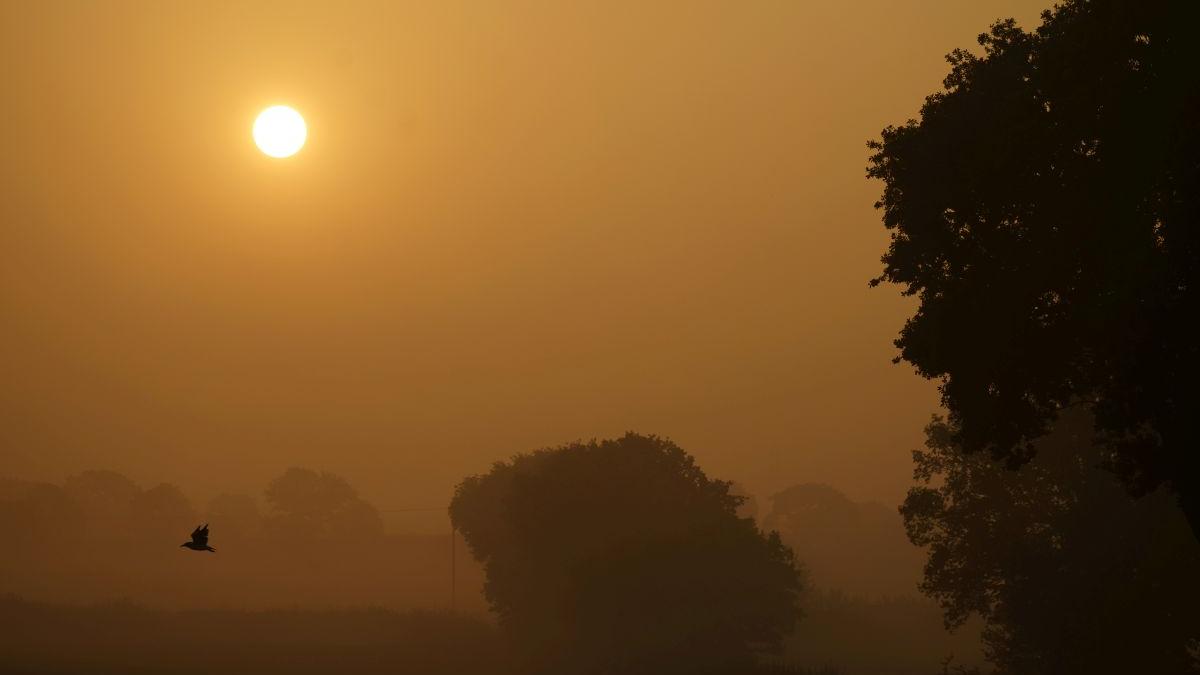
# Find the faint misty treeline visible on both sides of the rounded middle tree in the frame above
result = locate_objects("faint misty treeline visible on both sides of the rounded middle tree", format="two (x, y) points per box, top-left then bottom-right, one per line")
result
(0, 461), (922, 611)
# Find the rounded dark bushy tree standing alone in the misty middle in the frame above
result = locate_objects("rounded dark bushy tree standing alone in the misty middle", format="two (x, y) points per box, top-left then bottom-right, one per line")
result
(450, 434), (800, 673)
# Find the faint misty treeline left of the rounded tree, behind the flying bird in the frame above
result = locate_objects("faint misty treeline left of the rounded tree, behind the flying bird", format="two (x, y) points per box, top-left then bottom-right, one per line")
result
(0, 468), (486, 614)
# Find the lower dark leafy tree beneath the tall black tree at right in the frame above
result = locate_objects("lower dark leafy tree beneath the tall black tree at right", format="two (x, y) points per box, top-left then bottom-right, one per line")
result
(901, 411), (1200, 675)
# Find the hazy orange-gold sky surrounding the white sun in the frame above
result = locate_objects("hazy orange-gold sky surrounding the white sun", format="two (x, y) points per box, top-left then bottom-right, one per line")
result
(0, 0), (1048, 528)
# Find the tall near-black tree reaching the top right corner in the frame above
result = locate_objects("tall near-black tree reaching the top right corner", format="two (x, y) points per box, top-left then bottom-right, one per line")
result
(868, 0), (1200, 537)
